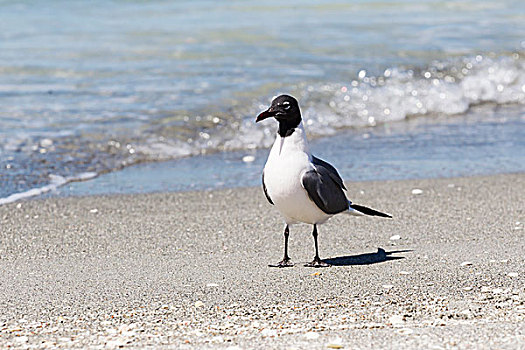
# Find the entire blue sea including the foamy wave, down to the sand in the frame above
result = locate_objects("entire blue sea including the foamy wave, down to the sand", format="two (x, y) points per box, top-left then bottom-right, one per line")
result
(0, 0), (525, 202)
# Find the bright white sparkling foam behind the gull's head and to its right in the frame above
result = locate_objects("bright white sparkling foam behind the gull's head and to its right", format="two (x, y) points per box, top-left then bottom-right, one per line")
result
(205, 53), (525, 156)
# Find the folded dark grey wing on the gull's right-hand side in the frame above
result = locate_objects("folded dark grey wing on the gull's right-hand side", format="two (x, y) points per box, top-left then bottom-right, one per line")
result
(301, 162), (349, 214)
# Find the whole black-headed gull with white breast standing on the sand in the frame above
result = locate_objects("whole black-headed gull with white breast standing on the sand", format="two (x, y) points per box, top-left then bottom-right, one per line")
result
(255, 95), (391, 267)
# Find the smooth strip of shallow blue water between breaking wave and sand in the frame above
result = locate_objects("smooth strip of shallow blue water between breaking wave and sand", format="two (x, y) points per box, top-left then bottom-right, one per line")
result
(0, 106), (525, 205)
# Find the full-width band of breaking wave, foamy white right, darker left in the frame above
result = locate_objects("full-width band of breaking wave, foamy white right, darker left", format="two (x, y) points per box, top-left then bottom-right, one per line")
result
(0, 52), (525, 204)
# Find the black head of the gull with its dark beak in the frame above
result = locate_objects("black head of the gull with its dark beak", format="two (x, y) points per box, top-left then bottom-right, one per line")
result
(255, 95), (301, 137)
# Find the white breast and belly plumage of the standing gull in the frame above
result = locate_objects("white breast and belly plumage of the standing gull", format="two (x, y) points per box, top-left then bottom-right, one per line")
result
(264, 123), (331, 224)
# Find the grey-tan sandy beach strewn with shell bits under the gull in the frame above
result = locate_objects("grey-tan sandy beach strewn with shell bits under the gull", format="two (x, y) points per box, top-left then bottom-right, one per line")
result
(0, 174), (525, 349)
